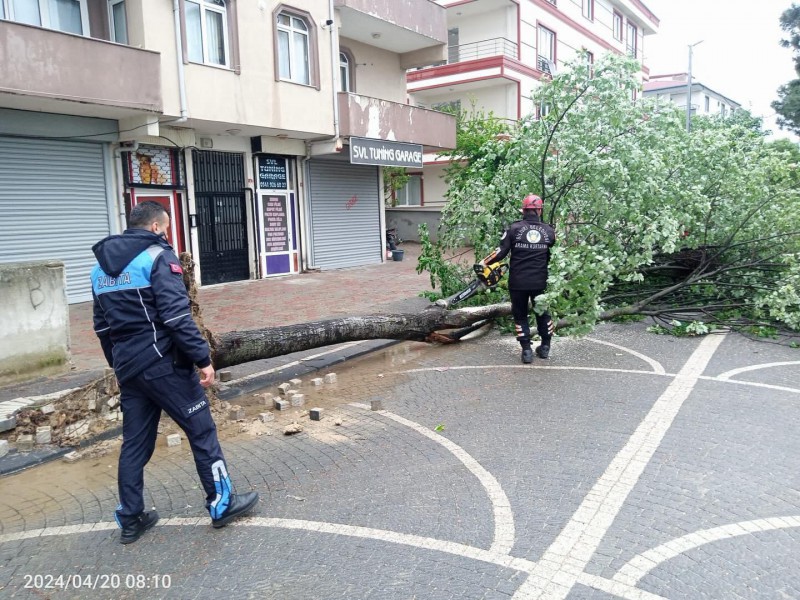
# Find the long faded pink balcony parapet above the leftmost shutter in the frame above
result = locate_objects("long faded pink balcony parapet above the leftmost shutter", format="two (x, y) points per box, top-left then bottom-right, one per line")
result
(0, 21), (163, 119)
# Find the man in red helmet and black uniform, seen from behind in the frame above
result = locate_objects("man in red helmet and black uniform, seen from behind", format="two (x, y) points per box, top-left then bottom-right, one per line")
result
(481, 194), (556, 364)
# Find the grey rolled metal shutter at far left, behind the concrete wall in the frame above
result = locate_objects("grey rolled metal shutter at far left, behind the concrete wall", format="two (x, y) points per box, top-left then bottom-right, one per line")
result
(0, 137), (109, 303)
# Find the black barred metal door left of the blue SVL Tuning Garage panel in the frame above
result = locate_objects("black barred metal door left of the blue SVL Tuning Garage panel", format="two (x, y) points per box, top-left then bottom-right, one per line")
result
(193, 151), (250, 285)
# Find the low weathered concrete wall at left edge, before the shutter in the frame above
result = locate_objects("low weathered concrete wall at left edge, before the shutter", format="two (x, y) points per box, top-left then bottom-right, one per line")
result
(0, 261), (69, 381)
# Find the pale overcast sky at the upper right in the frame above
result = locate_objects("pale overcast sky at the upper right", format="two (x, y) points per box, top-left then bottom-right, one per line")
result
(643, 0), (797, 140)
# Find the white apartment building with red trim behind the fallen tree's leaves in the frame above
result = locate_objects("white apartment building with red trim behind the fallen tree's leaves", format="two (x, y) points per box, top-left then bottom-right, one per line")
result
(390, 0), (659, 220)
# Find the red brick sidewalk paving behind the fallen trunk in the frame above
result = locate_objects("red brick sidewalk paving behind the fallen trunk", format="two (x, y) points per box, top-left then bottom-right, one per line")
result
(69, 243), (438, 371)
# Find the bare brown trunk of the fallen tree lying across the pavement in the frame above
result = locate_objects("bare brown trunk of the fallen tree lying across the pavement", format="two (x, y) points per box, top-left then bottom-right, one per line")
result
(211, 304), (511, 368)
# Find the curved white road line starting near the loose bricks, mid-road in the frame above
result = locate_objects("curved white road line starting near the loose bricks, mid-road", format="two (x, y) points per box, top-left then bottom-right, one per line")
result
(350, 402), (514, 554)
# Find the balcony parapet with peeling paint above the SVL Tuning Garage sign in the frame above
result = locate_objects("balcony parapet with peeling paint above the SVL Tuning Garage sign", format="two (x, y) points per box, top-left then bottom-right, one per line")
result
(339, 92), (456, 152)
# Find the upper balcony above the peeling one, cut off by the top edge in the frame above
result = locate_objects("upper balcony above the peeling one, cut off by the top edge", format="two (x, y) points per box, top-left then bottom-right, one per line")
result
(334, 0), (447, 69)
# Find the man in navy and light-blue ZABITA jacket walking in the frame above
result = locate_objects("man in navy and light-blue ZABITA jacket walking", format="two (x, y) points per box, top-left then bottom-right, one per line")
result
(92, 201), (258, 544)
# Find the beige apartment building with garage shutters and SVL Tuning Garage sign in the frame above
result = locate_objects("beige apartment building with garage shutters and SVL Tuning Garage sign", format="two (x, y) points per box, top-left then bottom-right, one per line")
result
(0, 0), (455, 302)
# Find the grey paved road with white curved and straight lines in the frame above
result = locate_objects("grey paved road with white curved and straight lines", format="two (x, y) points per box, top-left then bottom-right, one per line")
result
(0, 324), (800, 600)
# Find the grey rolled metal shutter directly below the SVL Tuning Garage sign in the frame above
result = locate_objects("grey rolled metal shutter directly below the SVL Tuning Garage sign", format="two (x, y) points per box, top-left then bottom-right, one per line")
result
(309, 160), (383, 269)
